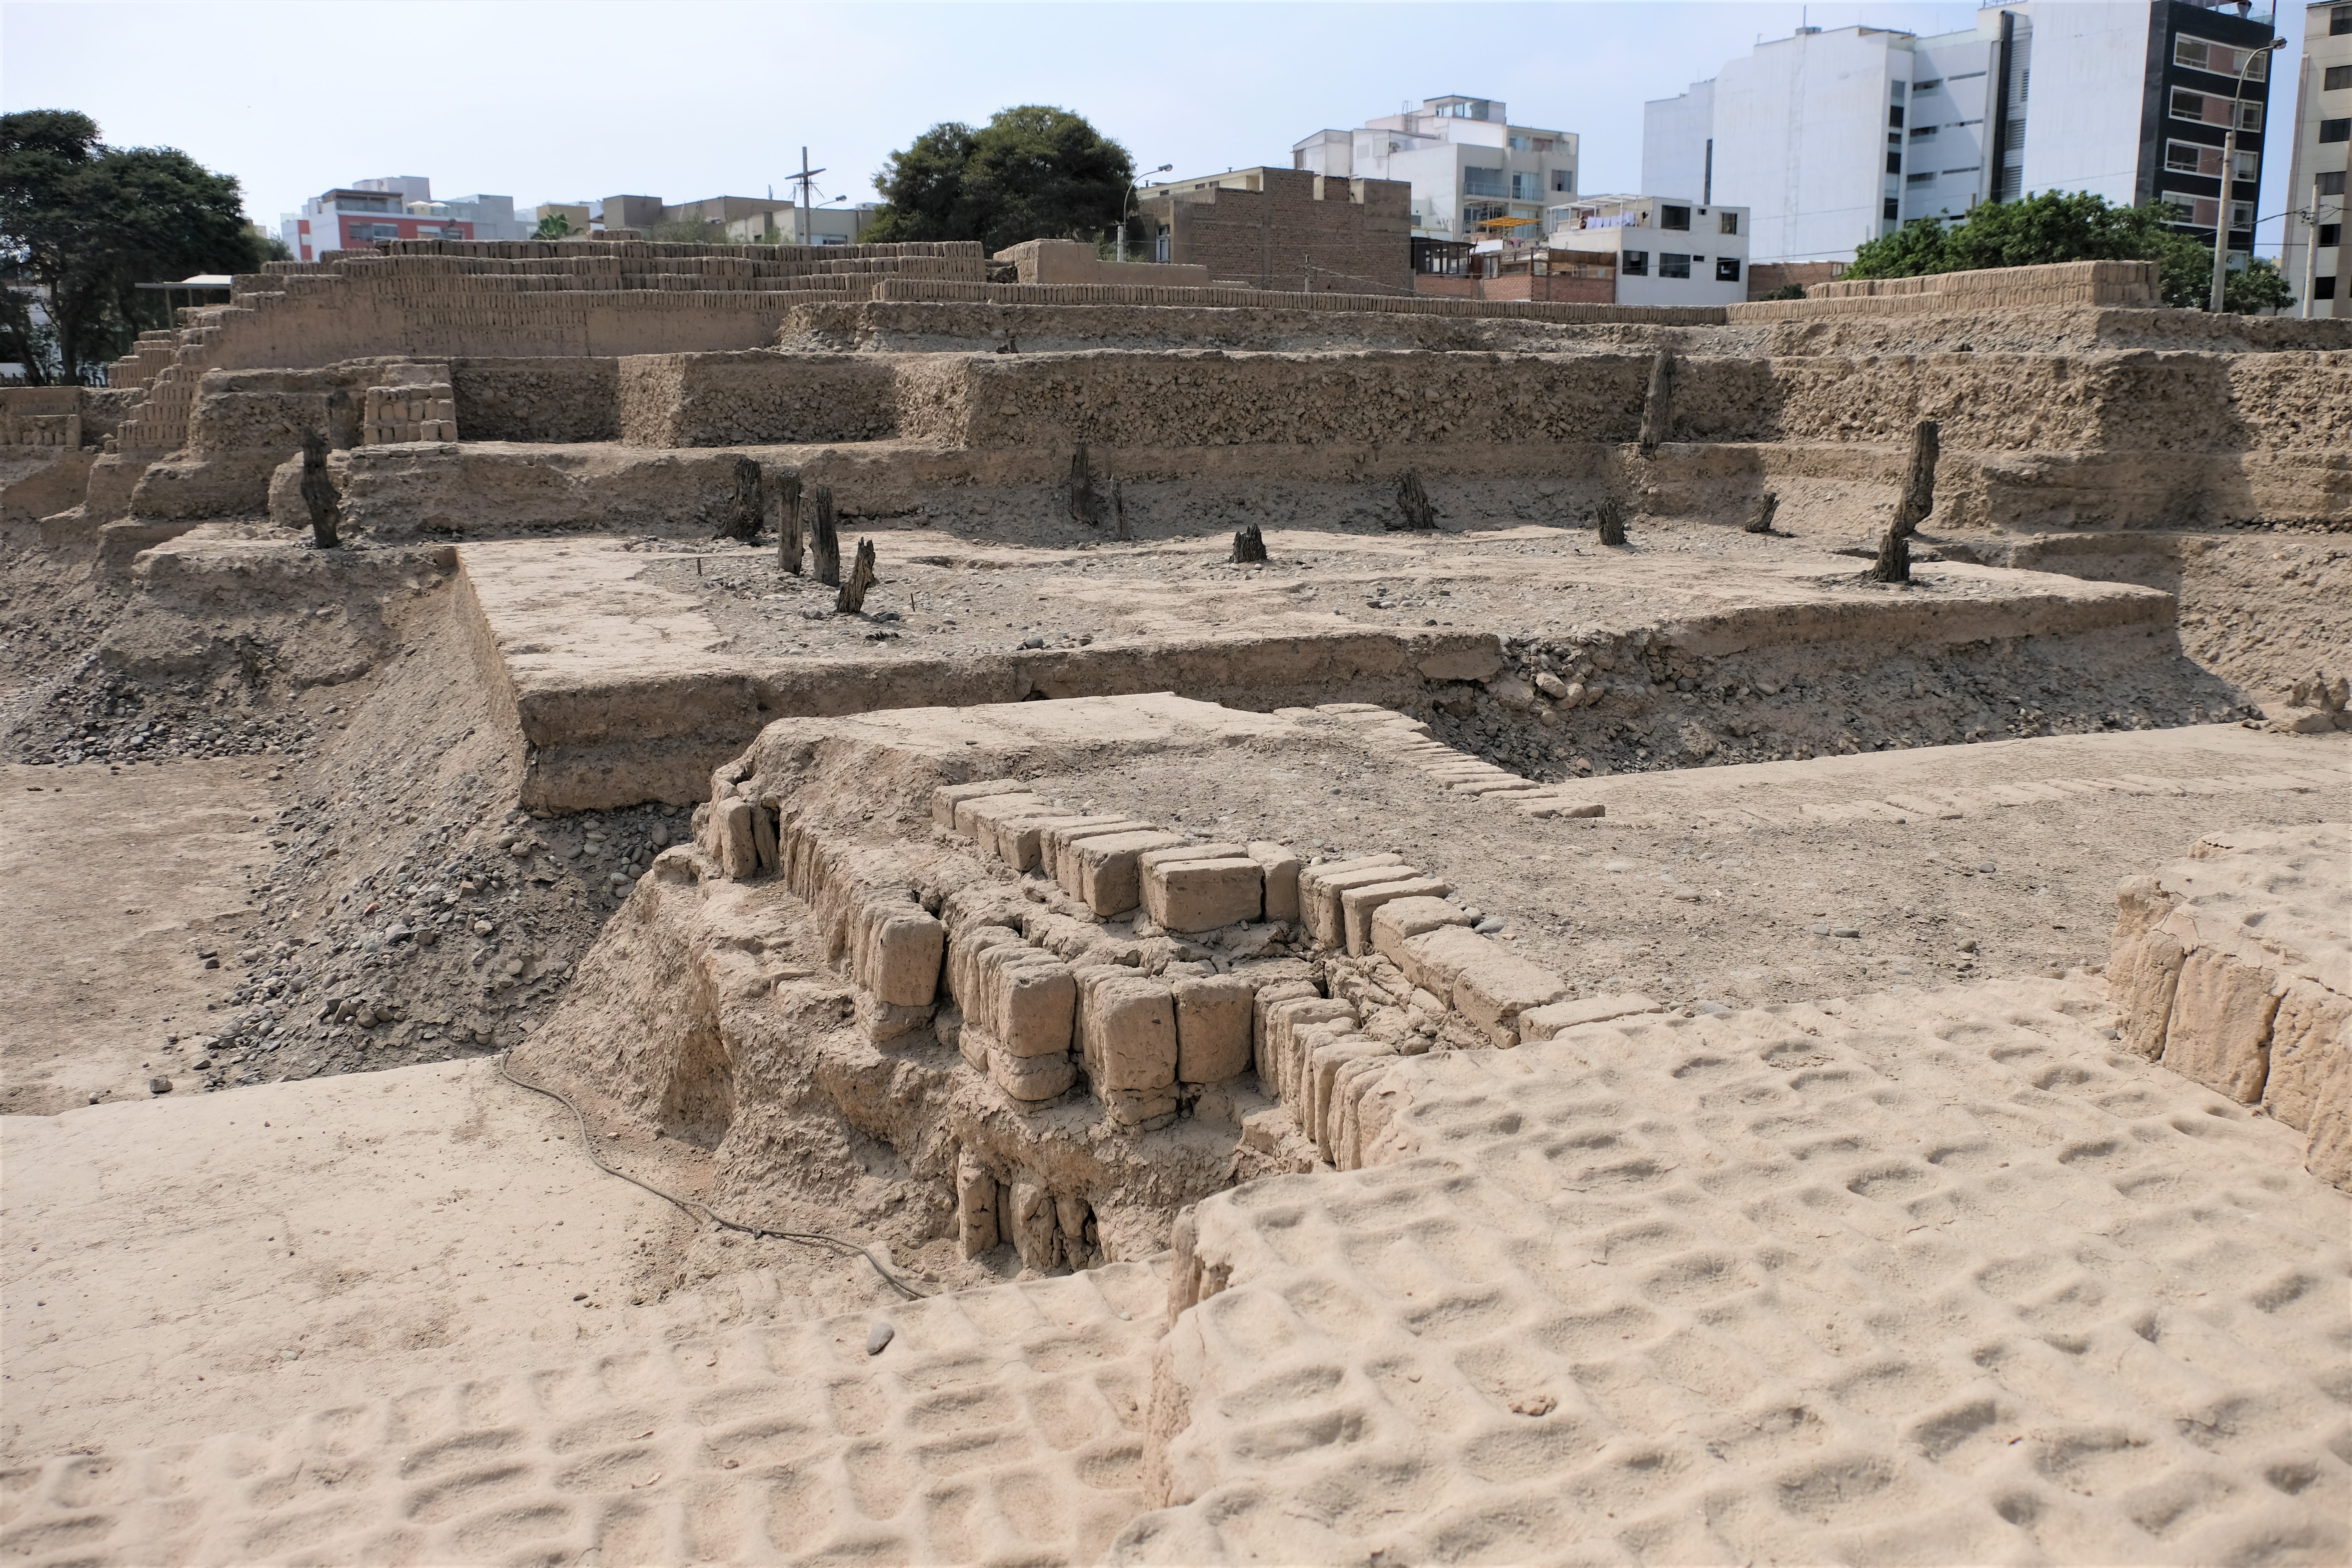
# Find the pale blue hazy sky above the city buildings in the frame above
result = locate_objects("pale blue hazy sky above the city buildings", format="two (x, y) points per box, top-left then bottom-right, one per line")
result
(0, 0), (2303, 252)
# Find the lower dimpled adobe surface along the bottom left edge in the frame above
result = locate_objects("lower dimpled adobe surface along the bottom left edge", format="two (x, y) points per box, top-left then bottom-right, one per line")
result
(0, 1262), (1167, 1566)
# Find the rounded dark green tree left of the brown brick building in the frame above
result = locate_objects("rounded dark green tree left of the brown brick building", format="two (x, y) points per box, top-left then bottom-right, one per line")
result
(866, 103), (1136, 254)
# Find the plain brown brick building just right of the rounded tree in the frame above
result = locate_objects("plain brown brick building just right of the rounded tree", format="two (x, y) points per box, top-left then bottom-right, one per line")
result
(1141, 169), (1414, 294)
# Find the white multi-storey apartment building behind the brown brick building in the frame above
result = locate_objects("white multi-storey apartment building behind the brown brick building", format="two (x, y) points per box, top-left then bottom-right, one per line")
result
(1291, 96), (1576, 240)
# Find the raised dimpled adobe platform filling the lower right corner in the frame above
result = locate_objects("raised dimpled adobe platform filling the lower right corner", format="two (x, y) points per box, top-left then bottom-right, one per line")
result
(1138, 983), (2352, 1563)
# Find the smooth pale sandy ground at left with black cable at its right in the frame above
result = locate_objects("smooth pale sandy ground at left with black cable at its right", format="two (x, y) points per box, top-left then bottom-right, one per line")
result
(0, 1060), (964, 1460)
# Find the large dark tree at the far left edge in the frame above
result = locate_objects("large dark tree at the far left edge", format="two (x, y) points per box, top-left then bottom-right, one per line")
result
(0, 108), (268, 383)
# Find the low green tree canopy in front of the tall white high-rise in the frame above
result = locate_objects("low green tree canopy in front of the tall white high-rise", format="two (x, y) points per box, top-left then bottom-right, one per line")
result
(1846, 191), (2291, 310)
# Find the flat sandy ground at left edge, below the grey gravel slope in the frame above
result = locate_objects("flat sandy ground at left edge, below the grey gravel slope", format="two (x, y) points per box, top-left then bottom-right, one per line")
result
(0, 759), (285, 1114)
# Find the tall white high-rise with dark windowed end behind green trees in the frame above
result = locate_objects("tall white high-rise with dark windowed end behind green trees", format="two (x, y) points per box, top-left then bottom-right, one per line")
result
(1642, 0), (2272, 261)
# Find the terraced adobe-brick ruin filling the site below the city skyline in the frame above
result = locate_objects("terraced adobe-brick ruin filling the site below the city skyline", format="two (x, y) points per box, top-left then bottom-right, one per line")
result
(0, 236), (2352, 1568)
